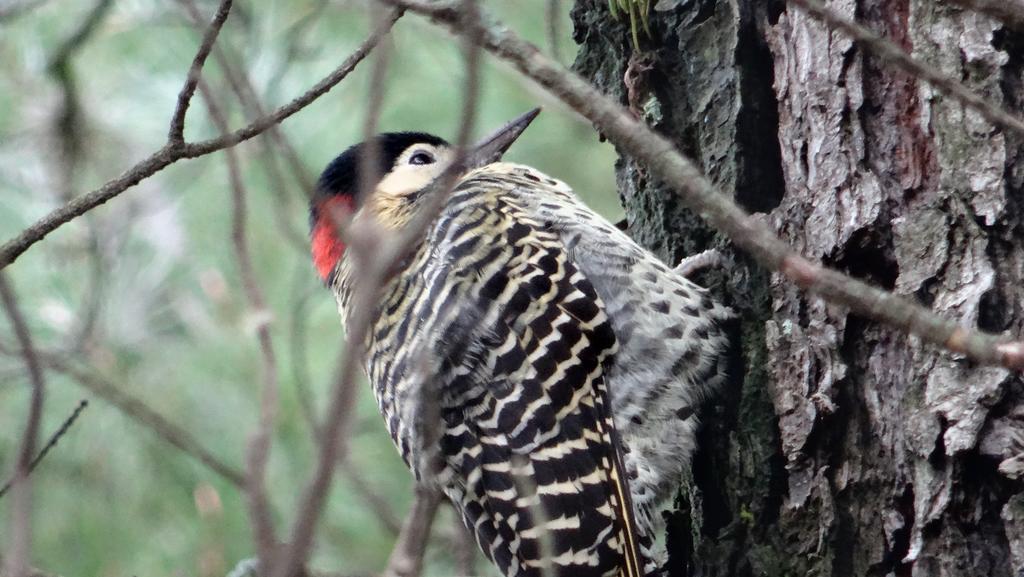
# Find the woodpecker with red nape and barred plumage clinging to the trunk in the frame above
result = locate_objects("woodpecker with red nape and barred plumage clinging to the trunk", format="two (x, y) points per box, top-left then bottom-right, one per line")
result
(310, 110), (731, 577)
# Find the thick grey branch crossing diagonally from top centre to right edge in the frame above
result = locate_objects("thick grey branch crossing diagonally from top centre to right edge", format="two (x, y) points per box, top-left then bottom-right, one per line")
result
(395, 0), (1024, 370)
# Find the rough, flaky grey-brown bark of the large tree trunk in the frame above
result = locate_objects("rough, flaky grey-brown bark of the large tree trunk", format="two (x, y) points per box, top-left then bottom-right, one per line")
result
(573, 0), (1024, 577)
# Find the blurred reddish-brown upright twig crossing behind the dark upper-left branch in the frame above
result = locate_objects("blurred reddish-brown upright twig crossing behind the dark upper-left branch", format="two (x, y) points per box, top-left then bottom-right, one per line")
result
(199, 82), (278, 567)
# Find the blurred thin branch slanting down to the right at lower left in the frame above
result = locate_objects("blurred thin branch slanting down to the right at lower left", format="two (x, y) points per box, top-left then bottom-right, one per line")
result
(42, 355), (246, 489)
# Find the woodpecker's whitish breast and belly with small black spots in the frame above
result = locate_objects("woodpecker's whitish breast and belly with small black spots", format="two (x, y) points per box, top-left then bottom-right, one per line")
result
(481, 164), (732, 562)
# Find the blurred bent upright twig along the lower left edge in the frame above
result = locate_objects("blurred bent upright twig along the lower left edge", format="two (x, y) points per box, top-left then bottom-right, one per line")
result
(0, 273), (46, 577)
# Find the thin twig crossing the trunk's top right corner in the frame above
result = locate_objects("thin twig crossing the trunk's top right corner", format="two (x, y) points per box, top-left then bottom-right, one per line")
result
(788, 0), (1024, 136)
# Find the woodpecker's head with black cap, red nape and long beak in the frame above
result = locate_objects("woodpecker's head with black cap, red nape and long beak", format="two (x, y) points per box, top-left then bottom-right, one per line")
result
(309, 109), (541, 282)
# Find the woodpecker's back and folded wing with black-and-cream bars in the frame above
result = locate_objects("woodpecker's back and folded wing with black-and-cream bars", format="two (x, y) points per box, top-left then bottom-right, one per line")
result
(346, 168), (644, 577)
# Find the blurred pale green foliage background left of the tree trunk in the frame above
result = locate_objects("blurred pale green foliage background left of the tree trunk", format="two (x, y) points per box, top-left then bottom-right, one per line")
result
(0, 0), (622, 577)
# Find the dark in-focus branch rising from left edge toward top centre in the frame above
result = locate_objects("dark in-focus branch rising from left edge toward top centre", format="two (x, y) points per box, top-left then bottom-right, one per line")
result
(0, 11), (401, 271)
